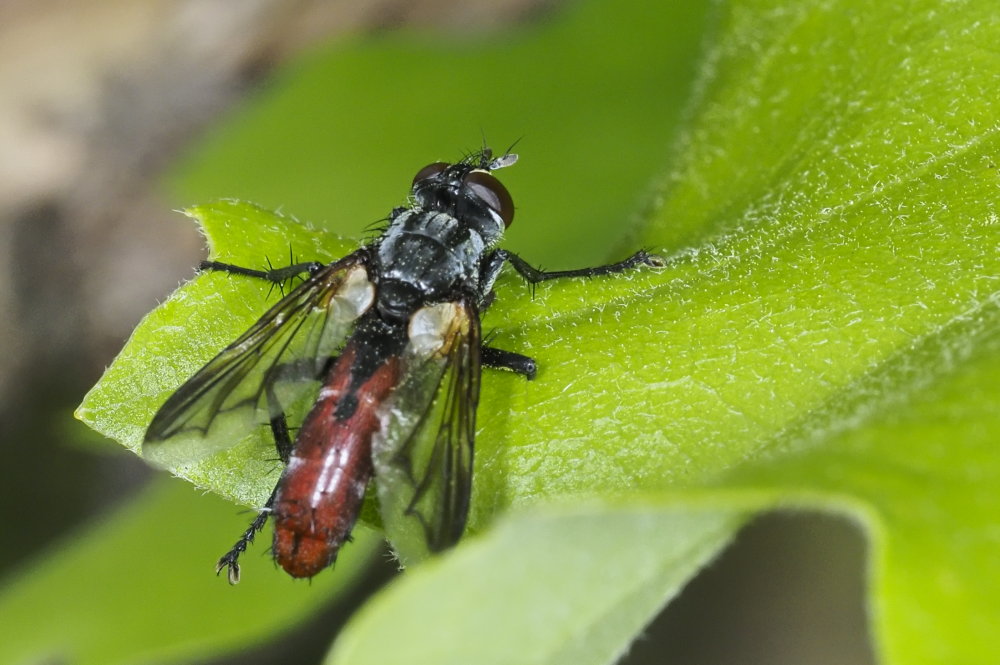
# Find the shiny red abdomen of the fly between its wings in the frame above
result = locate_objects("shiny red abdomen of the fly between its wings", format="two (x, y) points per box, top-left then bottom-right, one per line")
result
(273, 343), (399, 577)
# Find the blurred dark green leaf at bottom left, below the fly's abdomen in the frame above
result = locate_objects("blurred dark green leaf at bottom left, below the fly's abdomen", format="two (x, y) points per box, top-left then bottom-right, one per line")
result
(0, 480), (381, 665)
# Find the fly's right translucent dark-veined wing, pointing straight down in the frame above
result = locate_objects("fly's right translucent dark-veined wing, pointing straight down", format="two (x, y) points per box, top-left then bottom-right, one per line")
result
(373, 302), (480, 563)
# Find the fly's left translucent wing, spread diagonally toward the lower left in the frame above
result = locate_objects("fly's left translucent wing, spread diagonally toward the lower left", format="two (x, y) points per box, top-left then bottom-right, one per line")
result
(142, 252), (374, 466)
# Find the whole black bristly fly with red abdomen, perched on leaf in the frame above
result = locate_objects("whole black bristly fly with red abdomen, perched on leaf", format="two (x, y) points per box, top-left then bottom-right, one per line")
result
(143, 149), (662, 584)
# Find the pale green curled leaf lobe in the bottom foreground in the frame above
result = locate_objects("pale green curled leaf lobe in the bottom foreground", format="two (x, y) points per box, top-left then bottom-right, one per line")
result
(327, 501), (738, 665)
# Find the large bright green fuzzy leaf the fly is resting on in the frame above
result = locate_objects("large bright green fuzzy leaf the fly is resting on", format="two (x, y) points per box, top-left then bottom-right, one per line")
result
(72, 0), (1000, 664)
